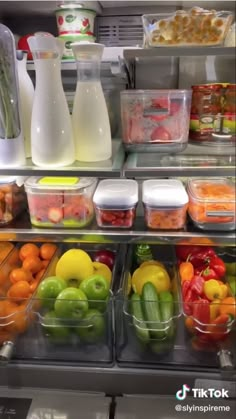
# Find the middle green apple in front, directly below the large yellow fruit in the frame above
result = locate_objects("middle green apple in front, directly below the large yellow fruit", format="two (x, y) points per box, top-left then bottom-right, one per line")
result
(54, 287), (88, 320)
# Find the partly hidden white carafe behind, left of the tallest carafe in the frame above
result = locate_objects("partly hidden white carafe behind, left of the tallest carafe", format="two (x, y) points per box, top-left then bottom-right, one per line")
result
(17, 51), (34, 157)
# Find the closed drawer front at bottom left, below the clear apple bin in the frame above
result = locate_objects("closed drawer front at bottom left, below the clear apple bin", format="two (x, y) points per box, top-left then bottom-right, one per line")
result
(0, 387), (111, 419)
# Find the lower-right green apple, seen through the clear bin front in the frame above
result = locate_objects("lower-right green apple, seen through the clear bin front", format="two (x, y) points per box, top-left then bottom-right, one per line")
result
(75, 309), (105, 343)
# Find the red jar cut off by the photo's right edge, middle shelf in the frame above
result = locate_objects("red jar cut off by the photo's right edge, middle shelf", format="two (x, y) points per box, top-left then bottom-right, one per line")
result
(223, 84), (236, 141)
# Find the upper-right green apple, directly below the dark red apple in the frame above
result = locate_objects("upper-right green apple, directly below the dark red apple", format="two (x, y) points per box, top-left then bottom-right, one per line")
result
(79, 275), (110, 301)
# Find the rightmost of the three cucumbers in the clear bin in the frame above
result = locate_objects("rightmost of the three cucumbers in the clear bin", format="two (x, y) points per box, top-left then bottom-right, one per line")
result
(159, 291), (174, 338)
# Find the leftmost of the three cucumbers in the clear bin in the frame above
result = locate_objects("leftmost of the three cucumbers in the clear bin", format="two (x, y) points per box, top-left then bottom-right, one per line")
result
(130, 293), (149, 343)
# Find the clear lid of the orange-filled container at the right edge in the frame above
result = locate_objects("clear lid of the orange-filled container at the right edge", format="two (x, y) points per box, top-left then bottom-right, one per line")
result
(187, 178), (235, 202)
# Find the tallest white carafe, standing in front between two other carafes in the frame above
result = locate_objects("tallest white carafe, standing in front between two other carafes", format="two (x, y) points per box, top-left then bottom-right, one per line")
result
(28, 33), (75, 167)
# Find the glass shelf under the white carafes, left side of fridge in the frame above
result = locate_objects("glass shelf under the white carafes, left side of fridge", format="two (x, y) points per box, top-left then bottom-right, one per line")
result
(0, 140), (125, 177)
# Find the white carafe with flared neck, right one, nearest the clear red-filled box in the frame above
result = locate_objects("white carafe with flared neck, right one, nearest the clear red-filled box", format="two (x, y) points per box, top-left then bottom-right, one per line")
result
(72, 43), (112, 162)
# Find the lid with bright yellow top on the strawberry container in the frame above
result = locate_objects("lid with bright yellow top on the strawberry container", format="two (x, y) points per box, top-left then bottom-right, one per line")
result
(25, 176), (97, 190)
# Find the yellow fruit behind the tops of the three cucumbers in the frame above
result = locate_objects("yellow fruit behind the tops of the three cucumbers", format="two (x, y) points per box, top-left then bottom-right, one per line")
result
(132, 265), (171, 295)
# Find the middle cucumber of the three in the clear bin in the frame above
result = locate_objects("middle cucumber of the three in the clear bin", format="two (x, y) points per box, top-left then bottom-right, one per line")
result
(142, 282), (165, 339)
